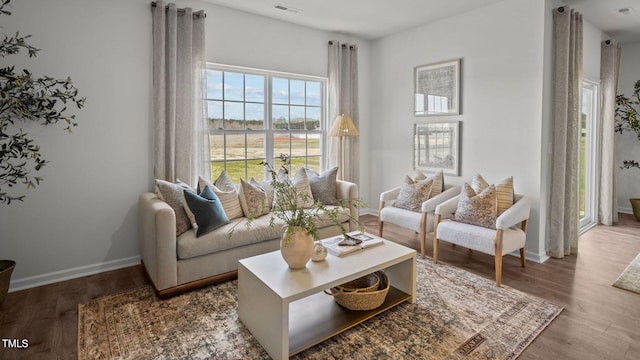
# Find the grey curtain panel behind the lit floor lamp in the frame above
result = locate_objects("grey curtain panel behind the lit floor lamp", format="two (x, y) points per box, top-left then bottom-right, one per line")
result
(325, 40), (360, 184)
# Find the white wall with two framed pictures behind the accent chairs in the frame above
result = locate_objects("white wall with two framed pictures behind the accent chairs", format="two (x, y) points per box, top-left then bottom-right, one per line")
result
(371, 0), (544, 259)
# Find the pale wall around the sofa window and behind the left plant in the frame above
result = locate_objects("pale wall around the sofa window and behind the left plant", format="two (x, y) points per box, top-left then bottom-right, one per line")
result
(0, 0), (370, 290)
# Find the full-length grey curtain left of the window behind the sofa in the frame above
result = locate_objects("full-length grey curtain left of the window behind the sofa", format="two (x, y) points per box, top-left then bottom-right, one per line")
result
(151, 1), (211, 185)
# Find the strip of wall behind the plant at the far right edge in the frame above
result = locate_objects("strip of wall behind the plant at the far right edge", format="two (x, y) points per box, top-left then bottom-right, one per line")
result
(616, 43), (640, 213)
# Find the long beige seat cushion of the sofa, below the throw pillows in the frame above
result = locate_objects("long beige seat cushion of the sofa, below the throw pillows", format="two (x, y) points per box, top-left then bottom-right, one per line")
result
(176, 208), (349, 259)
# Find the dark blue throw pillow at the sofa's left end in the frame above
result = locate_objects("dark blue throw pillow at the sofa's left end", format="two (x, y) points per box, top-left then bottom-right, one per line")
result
(184, 186), (230, 237)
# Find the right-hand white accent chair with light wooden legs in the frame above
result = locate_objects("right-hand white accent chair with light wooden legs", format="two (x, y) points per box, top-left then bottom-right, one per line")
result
(433, 194), (531, 287)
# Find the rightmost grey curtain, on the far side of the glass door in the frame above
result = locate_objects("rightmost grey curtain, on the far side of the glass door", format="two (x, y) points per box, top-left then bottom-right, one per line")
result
(598, 40), (622, 225)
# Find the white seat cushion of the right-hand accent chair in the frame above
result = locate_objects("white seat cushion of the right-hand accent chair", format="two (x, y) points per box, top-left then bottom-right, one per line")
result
(437, 219), (526, 256)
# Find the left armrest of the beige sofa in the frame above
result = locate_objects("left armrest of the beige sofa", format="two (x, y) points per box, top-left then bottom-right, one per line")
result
(138, 193), (178, 290)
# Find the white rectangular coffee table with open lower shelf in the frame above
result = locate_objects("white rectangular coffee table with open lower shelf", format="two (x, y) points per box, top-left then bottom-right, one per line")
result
(238, 234), (416, 359)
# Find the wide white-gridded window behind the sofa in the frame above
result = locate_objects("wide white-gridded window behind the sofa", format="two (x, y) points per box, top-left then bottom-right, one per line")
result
(206, 64), (326, 183)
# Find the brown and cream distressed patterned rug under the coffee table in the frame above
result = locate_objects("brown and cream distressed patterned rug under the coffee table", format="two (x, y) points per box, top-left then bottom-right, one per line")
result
(78, 258), (562, 360)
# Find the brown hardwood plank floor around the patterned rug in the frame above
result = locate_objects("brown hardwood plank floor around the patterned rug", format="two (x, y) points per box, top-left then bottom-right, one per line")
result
(0, 214), (640, 360)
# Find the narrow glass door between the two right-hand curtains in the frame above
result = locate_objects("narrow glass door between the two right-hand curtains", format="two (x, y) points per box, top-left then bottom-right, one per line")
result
(578, 79), (600, 233)
